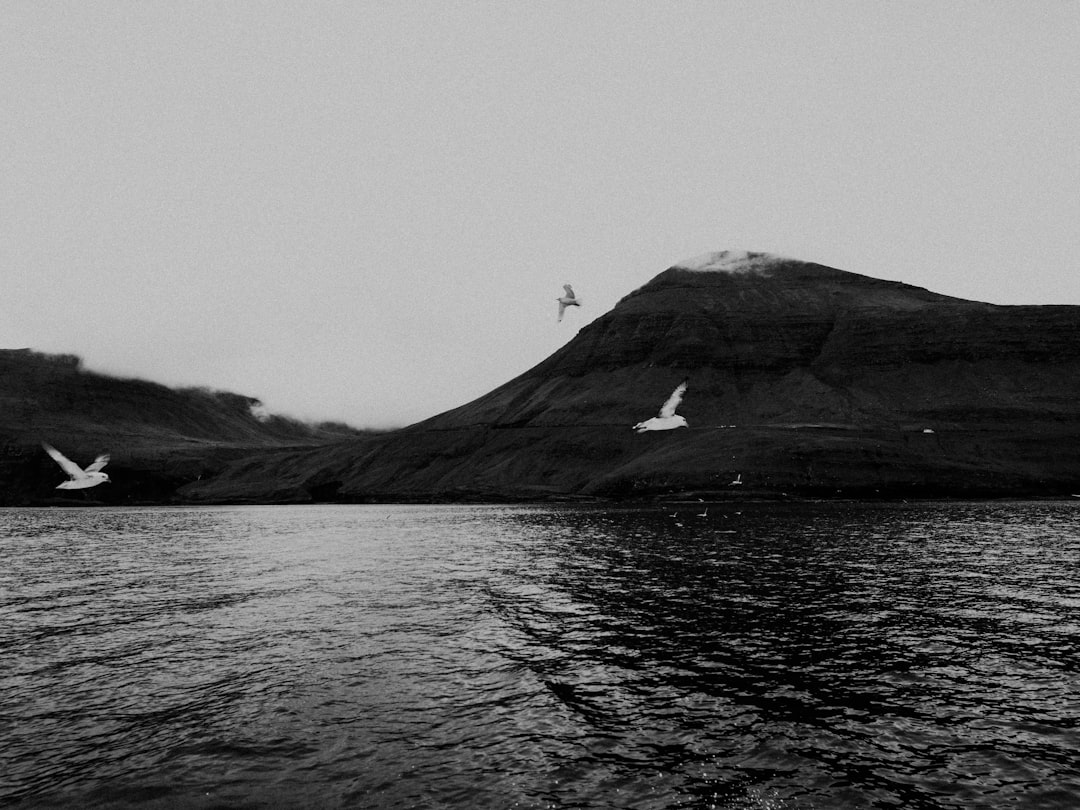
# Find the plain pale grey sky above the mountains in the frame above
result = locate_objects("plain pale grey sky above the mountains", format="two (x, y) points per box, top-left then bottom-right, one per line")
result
(0, 0), (1080, 428)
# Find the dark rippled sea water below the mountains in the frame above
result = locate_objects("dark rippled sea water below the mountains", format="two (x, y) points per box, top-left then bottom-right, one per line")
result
(0, 502), (1080, 810)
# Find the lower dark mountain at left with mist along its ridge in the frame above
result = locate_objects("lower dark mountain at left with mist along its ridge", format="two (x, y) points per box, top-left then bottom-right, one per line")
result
(0, 349), (367, 505)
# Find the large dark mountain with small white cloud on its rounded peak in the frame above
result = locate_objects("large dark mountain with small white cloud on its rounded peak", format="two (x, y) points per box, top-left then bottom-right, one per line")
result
(179, 252), (1080, 501)
